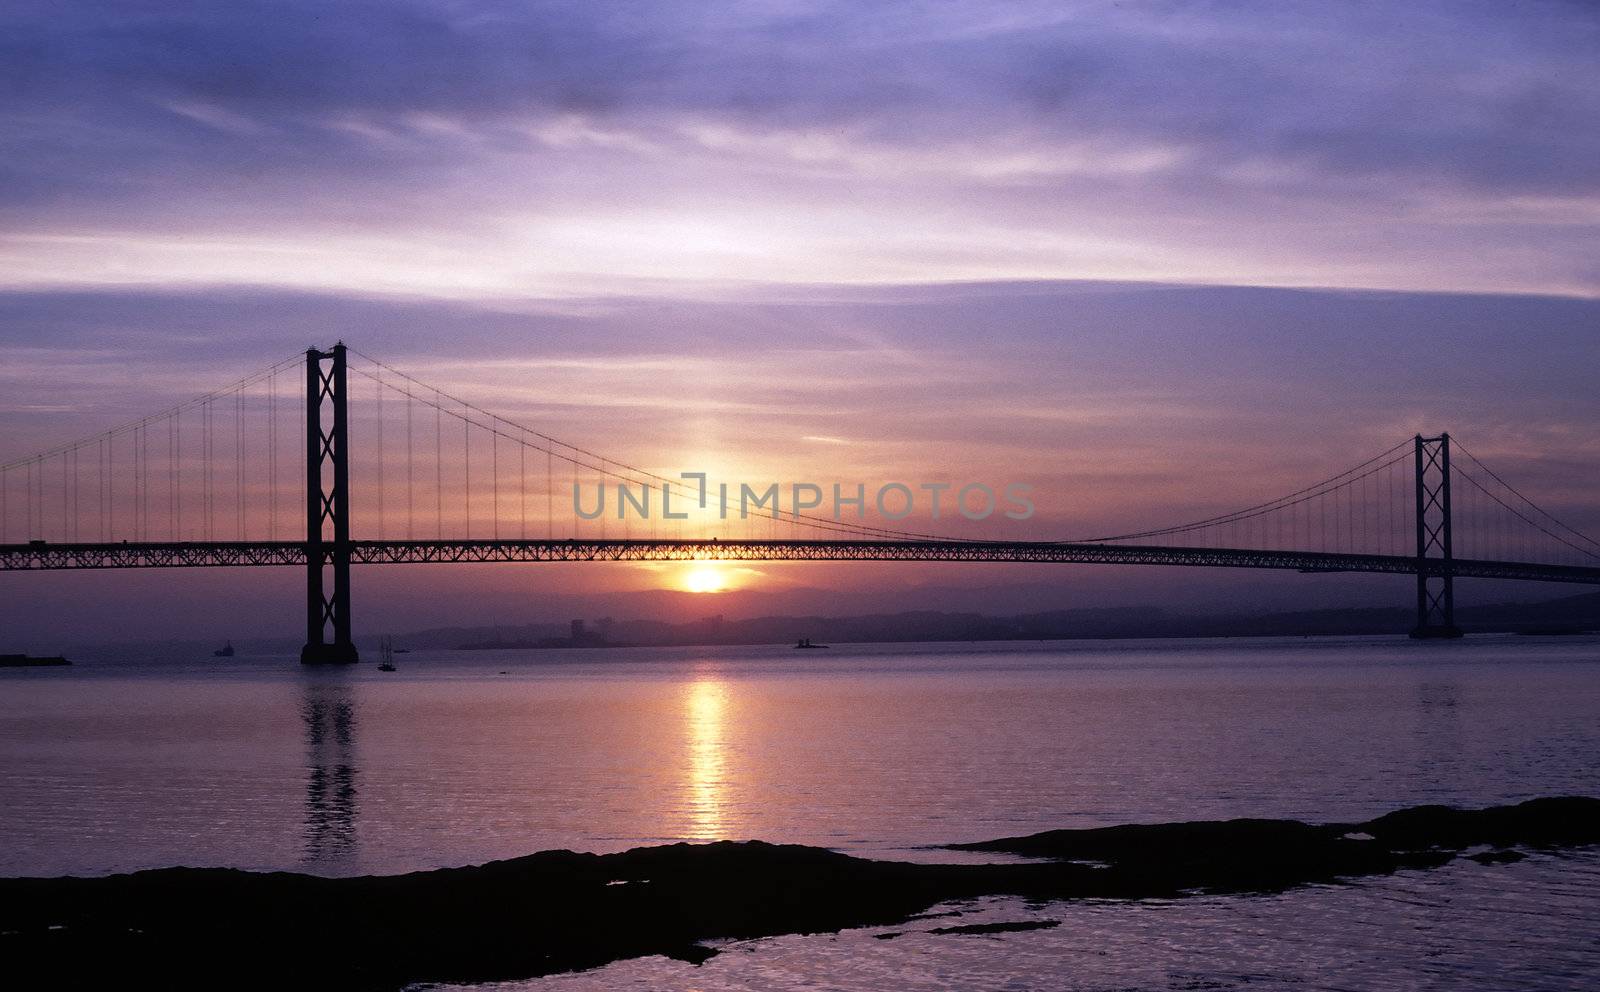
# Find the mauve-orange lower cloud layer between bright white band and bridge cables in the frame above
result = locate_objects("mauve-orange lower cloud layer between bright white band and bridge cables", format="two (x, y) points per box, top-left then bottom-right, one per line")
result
(0, 283), (1600, 512)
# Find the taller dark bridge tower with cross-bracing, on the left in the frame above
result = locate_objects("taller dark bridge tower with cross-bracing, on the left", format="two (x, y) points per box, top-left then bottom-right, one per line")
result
(301, 342), (357, 664)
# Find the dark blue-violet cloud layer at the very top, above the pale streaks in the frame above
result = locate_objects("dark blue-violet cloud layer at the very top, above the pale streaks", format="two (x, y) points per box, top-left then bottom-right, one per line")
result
(0, 0), (1600, 182)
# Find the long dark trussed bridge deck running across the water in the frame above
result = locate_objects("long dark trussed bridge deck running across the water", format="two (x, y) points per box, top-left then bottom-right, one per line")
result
(0, 539), (1600, 584)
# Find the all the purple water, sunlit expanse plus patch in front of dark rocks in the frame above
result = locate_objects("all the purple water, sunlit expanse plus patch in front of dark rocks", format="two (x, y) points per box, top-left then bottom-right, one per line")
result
(0, 637), (1600, 989)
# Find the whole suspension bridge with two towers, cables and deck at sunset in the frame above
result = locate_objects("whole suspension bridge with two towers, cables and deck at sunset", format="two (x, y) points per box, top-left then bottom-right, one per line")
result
(0, 344), (1600, 664)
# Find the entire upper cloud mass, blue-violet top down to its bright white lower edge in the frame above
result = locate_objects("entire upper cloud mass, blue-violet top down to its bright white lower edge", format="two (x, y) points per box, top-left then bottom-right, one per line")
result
(0, 0), (1600, 298)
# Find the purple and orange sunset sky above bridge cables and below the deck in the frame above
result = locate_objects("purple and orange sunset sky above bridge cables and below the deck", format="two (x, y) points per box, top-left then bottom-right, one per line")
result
(0, 0), (1600, 638)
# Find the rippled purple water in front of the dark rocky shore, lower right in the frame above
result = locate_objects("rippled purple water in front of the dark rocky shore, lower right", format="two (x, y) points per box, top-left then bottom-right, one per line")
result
(478, 853), (1600, 992)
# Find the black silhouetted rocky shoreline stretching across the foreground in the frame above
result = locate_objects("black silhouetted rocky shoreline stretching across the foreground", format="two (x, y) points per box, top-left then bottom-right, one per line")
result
(0, 797), (1600, 989)
